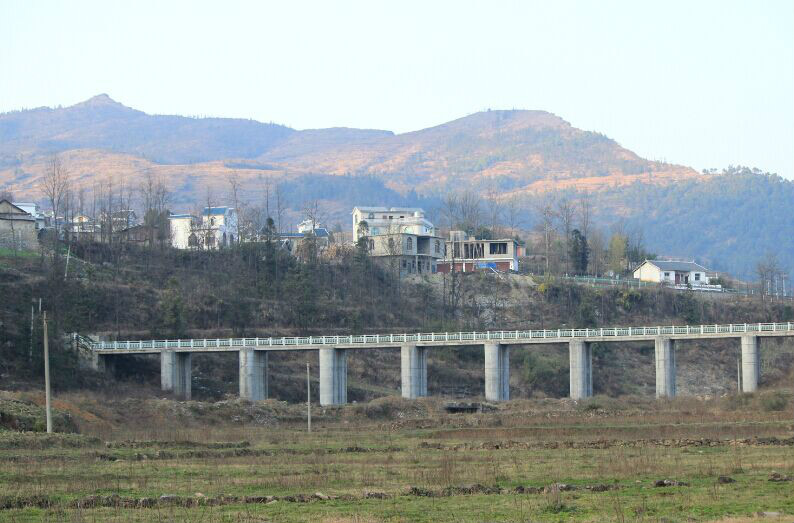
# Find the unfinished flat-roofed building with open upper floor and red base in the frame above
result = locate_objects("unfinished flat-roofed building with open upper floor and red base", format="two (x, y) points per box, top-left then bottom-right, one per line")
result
(438, 231), (519, 273)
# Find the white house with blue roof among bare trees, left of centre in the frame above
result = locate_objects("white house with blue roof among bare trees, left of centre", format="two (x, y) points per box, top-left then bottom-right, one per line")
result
(169, 207), (240, 249)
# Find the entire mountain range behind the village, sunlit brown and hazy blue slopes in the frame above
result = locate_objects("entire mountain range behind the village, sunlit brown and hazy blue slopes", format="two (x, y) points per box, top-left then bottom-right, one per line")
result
(0, 95), (794, 278)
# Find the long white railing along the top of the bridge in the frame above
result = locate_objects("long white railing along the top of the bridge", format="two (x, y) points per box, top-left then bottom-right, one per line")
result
(86, 322), (794, 350)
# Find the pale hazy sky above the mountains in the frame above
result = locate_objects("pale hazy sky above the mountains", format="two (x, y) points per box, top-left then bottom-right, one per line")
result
(0, 0), (794, 179)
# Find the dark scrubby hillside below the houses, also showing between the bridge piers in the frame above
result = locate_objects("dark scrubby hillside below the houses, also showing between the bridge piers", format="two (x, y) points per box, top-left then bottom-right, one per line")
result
(0, 243), (794, 401)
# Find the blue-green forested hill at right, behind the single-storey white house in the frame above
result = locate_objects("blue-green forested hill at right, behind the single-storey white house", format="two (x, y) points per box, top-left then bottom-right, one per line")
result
(599, 168), (794, 279)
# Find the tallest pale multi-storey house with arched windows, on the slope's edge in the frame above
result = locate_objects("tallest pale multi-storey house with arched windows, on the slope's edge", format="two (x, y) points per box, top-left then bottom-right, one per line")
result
(353, 207), (444, 275)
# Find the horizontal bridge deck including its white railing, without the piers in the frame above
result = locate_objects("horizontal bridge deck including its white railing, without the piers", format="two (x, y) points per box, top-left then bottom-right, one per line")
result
(78, 322), (794, 354)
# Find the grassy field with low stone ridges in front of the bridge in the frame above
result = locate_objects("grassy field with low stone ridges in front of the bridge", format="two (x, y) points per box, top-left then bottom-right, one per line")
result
(0, 396), (794, 523)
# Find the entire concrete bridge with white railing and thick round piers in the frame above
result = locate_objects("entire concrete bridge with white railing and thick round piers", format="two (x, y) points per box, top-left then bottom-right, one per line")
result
(74, 322), (794, 405)
